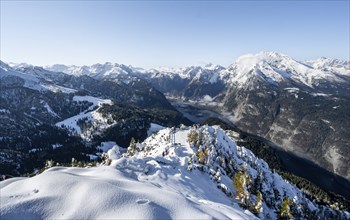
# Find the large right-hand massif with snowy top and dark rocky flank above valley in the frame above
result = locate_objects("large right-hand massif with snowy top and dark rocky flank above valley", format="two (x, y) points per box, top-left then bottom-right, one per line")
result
(218, 53), (350, 179)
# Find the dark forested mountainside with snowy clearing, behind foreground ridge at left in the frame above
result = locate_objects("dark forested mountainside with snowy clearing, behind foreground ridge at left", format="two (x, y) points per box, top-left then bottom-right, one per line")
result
(0, 63), (190, 176)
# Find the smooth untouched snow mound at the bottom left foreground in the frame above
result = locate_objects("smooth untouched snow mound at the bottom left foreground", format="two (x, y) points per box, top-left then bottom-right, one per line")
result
(0, 155), (254, 219)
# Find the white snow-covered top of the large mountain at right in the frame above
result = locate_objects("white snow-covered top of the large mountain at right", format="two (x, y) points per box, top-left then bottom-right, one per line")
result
(228, 52), (349, 88)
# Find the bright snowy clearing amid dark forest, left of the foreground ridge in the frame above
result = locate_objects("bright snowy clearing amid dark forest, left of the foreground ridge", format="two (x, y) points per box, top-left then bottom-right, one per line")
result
(56, 96), (113, 139)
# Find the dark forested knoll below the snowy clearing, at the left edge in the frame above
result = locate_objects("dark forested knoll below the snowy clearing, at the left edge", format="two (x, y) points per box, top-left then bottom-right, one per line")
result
(0, 125), (98, 176)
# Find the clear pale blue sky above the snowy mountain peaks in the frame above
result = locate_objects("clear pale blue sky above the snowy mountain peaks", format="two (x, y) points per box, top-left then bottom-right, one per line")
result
(0, 1), (350, 67)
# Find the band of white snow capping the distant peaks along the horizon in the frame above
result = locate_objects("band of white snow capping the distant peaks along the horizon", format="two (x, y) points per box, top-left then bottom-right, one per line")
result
(3, 51), (350, 93)
